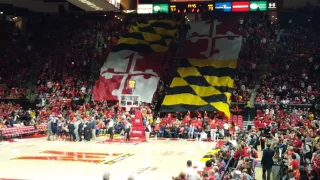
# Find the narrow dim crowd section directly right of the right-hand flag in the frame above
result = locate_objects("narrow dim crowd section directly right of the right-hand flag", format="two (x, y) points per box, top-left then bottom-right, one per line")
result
(232, 15), (278, 102)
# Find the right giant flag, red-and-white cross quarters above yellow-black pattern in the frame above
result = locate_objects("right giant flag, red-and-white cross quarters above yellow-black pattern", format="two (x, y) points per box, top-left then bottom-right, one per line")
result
(161, 21), (242, 117)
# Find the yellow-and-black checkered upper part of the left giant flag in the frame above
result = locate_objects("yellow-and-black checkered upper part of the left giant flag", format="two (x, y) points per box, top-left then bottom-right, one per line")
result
(112, 20), (179, 52)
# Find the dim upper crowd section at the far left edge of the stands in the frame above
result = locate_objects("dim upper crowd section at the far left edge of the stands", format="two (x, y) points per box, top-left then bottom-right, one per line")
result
(0, 21), (30, 99)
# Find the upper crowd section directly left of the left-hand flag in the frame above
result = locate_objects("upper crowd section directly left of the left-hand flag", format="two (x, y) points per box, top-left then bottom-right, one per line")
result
(33, 19), (111, 102)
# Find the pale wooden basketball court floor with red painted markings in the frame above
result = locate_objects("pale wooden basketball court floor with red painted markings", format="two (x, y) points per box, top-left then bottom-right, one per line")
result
(0, 137), (223, 180)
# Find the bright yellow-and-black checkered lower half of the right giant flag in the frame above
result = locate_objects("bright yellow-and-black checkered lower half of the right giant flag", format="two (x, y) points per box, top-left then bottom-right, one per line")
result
(161, 59), (237, 117)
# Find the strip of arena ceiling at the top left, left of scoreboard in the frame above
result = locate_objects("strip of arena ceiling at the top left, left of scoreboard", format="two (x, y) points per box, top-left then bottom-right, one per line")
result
(0, 0), (119, 12)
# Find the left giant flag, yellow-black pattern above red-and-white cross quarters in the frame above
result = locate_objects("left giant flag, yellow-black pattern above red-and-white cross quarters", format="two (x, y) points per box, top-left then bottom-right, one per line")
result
(93, 20), (180, 103)
